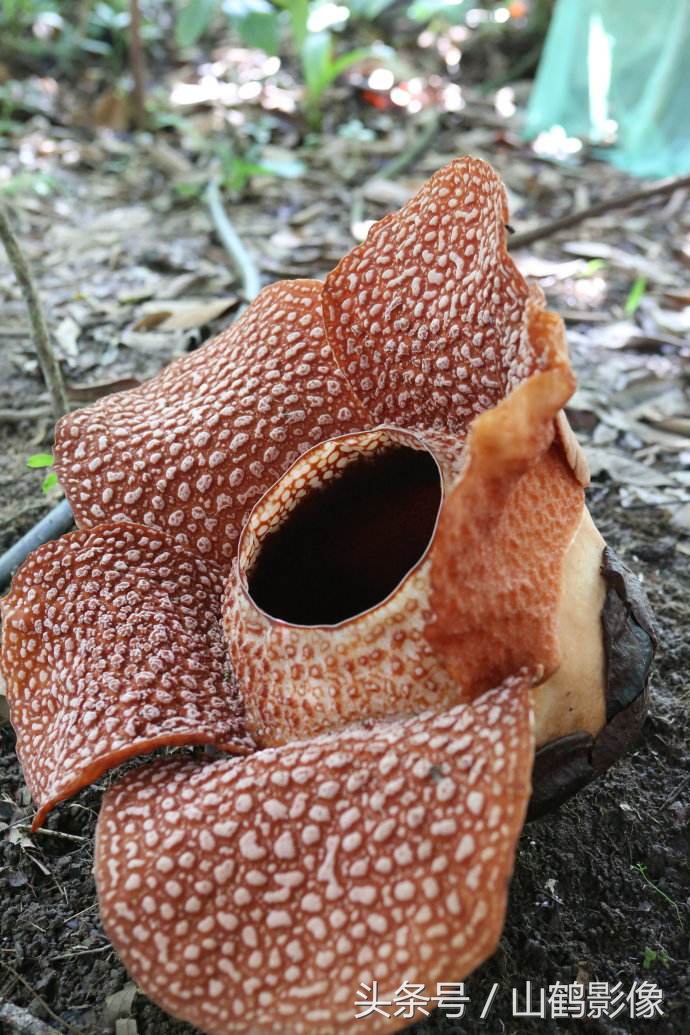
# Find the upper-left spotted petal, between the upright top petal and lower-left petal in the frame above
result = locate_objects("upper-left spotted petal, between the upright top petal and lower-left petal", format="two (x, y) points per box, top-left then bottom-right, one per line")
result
(55, 280), (370, 570)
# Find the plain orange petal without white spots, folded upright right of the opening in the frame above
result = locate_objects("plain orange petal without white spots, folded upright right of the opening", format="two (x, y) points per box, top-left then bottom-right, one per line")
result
(427, 303), (583, 698)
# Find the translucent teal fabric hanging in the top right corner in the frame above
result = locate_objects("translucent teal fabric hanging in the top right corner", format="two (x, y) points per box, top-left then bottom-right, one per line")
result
(524, 0), (690, 177)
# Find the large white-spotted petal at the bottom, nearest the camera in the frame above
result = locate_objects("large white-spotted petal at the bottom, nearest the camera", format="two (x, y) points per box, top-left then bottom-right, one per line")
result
(95, 678), (534, 1035)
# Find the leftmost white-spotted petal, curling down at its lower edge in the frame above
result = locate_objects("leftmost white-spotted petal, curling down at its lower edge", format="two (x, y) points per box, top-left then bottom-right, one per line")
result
(0, 524), (253, 826)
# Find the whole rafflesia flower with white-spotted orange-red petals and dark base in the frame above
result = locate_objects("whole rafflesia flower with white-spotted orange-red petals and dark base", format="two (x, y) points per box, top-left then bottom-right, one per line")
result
(2, 158), (652, 1035)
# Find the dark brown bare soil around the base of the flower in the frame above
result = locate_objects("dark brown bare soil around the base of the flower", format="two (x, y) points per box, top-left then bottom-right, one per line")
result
(0, 484), (690, 1035)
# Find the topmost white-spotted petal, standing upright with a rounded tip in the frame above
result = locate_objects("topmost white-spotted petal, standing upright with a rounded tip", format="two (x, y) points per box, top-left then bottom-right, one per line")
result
(324, 158), (540, 435)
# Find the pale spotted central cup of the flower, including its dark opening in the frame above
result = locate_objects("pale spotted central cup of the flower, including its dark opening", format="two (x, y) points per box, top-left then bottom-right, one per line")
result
(223, 427), (459, 747)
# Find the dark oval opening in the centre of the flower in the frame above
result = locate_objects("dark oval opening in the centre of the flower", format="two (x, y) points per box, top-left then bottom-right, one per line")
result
(247, 444), (442, 625)
